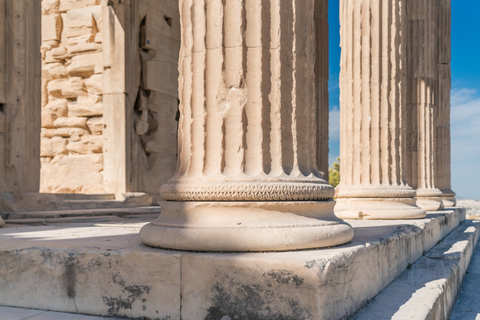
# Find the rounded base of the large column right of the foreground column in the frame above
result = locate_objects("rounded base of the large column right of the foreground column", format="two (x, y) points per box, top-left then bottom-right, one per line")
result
(335, 198), (427, 220)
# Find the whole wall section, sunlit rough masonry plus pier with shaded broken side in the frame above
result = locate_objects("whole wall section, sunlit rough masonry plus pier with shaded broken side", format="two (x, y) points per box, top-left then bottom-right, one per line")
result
(40, 0), (180, 198)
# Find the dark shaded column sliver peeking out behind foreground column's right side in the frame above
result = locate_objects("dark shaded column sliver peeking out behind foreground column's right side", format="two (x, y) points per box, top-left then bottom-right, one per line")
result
(315, 0), (329, 181)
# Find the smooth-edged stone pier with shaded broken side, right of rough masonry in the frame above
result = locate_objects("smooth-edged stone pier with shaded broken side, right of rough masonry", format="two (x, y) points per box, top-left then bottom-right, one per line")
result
(103, 0), (180, 200)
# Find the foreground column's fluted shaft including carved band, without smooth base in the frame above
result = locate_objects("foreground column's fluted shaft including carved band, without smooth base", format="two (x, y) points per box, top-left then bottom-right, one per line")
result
(162, 0), (333, 201)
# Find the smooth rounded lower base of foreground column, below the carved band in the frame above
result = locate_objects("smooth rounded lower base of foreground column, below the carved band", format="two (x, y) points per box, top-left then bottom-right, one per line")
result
(140, 201), (353, 251)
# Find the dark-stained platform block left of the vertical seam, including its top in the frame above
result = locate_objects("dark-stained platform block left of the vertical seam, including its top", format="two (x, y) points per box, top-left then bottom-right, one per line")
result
(0, 215), (181, 319)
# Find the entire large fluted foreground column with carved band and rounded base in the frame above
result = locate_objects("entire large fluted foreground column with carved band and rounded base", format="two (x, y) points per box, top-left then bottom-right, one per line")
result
(140, 0), (353, 251)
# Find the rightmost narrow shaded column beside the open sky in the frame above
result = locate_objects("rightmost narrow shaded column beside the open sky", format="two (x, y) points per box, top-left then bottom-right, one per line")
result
(435, 0), (456, 207)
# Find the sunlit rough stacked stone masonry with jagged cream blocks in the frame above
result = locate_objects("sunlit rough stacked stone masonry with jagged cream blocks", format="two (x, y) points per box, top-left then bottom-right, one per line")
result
(40, 0), (106, 193)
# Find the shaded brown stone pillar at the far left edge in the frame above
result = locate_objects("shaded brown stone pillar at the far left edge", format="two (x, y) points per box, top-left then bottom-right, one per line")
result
(0, 0), (41, 226)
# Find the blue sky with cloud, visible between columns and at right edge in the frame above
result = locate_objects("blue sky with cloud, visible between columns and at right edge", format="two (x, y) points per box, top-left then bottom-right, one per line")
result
(329, 0), (480, 199)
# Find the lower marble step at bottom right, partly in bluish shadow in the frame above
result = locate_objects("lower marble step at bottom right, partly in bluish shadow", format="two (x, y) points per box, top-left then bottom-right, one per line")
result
(350, 220), (480, 320)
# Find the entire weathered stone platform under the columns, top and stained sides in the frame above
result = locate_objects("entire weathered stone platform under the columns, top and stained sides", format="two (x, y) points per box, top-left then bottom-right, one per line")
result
(0, 208), (465, 320)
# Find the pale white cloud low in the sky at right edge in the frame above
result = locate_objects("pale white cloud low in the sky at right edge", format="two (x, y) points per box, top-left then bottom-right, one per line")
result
(451, 88), (480, 198)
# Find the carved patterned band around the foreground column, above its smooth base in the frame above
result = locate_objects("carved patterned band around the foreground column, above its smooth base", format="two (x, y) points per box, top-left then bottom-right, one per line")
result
(160, 181), (335, 201)
